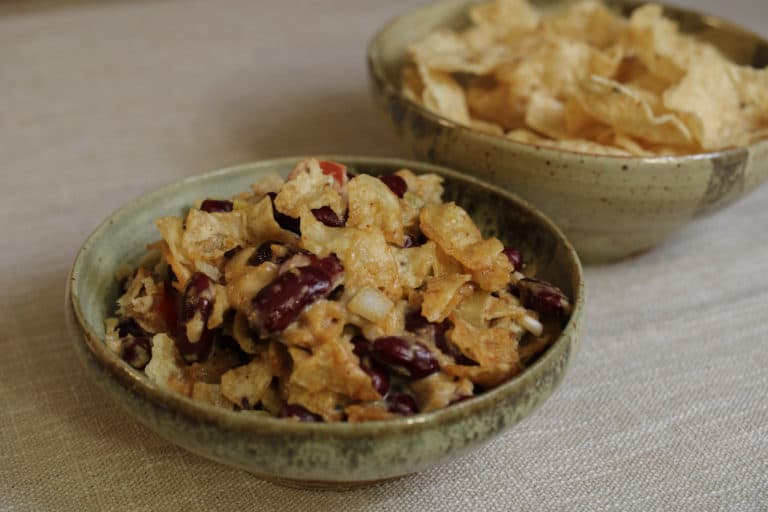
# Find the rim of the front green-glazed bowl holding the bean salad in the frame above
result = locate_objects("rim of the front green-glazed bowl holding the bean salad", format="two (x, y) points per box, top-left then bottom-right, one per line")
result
(65, 155), (584, 438)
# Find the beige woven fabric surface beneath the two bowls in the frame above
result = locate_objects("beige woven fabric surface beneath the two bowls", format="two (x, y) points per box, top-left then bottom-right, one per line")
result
(0, 0), (768, 512)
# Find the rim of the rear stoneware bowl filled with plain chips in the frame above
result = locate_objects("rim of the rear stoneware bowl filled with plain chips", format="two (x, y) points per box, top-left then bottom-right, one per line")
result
(366, 0), (768, 160)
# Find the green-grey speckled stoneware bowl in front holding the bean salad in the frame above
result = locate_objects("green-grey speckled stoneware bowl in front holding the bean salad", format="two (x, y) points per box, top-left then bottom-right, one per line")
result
(66, 156), (584, 488)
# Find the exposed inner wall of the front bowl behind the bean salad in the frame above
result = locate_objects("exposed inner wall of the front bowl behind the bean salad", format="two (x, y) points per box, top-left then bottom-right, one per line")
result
(72, 156), (580, 344)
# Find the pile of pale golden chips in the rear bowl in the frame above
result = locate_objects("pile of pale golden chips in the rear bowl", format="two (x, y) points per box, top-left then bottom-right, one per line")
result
(402, 0), (768, 156)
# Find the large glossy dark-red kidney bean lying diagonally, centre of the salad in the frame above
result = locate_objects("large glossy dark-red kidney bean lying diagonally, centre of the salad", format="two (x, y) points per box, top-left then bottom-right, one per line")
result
(249, 255), (343, 332)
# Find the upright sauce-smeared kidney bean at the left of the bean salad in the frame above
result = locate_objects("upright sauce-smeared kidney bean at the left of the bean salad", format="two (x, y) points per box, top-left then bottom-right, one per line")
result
(176, 272), (216, 362)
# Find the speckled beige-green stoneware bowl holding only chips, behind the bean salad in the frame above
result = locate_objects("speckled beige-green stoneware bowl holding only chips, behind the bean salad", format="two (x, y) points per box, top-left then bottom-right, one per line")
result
(368, 0), (768, 263)
